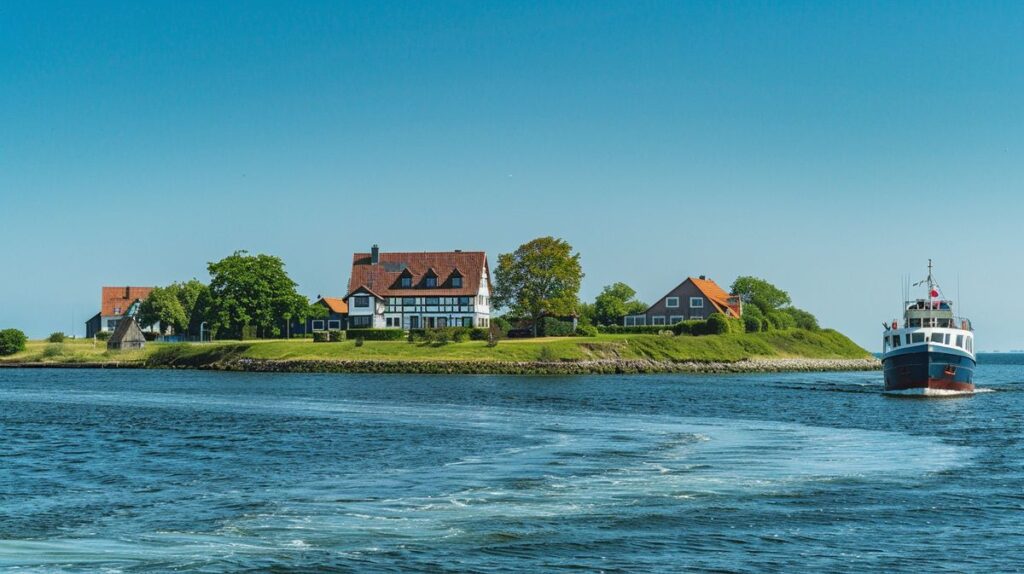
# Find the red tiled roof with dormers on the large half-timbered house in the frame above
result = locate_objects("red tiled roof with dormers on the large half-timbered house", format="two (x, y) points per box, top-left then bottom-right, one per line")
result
(345, 251), (489, 299)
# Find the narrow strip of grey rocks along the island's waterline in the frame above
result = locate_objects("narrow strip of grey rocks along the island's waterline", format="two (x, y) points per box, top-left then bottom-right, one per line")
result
(203, 358), (882, 374)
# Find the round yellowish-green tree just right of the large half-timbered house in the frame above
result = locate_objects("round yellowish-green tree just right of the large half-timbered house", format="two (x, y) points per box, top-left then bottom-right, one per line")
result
(493, 237), (584, 337)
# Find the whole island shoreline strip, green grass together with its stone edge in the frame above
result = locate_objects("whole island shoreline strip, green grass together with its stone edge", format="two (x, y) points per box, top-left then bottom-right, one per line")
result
(0, 329), (878, 374)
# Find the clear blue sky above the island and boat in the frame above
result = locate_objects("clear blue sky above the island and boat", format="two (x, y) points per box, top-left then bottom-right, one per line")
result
(0, 1), (1024, 350)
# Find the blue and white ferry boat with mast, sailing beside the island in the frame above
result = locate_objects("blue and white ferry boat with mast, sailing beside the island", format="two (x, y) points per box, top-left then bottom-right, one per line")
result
(882, 260), (977, 396)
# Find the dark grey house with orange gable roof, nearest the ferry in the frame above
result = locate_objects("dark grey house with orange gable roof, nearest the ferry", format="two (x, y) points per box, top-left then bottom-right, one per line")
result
(623, 275), (743, 326)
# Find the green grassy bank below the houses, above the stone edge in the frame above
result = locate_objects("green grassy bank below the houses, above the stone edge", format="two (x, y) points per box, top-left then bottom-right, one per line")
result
(0, 329), (869, 368)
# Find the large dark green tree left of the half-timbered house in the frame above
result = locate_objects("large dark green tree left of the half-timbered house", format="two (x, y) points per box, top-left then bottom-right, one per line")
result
(207, 251), (309, 338)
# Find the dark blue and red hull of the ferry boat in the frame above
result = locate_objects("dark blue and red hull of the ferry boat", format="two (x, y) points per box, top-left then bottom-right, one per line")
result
(882, 345), (976, 396)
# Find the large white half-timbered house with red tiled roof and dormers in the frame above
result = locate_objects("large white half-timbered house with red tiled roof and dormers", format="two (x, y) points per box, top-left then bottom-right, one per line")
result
(344, 246), (492, 329)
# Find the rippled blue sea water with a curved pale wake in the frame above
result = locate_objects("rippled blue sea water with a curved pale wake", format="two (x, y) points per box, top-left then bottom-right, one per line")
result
(0, 355), (1024, 572)
